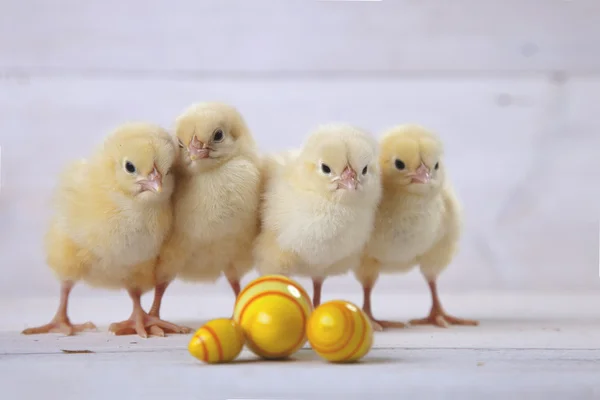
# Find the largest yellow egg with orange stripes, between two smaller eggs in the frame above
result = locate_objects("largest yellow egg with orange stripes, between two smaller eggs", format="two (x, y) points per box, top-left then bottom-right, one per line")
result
(233, 275), (313, 359)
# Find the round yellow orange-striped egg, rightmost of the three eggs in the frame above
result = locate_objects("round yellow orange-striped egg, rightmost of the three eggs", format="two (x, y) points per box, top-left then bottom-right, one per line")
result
(306, 300), (373, 362)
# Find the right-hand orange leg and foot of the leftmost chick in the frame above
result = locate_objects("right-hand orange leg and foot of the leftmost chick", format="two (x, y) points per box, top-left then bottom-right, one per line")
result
(108, 288), (190, 338)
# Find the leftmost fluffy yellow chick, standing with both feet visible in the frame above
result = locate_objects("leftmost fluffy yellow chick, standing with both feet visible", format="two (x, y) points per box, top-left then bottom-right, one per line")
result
(23, 123), (189, 337)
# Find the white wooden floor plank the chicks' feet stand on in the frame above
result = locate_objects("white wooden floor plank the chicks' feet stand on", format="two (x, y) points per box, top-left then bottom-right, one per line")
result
(0, 286), (600, 354)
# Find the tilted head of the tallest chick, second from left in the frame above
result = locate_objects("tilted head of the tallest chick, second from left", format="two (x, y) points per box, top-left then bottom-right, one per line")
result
(175, 102), (255, 172)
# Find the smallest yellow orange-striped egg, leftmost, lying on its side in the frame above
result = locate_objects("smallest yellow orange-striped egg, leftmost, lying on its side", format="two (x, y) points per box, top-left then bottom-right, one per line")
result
(188, 318), (244, 364)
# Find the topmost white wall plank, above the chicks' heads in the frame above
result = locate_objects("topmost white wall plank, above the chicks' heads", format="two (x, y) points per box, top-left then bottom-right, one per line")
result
(0, 0), (600, 76)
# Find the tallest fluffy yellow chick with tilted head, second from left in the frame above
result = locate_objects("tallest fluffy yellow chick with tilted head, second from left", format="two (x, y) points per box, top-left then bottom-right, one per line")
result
(150, 102), (260, 316)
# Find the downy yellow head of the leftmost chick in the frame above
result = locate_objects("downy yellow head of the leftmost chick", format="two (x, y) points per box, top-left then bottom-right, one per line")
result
(99, 122), (177, 201)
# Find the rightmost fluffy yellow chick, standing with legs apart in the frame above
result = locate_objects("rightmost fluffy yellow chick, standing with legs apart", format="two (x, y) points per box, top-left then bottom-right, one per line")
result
(354, 124), (478, 330)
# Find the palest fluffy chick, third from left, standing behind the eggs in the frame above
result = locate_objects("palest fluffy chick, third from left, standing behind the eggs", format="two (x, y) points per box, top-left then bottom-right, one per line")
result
(254, 124), (381, 307)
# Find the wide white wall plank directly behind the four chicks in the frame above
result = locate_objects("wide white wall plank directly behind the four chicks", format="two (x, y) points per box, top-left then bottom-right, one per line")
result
(0, 74), (600, 296)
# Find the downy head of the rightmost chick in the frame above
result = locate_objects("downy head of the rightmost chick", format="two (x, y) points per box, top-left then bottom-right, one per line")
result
(379, 124), (445, 195)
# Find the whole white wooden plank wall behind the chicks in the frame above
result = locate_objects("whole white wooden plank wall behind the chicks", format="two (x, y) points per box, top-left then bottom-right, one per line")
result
(0, 0), (600, 296)
